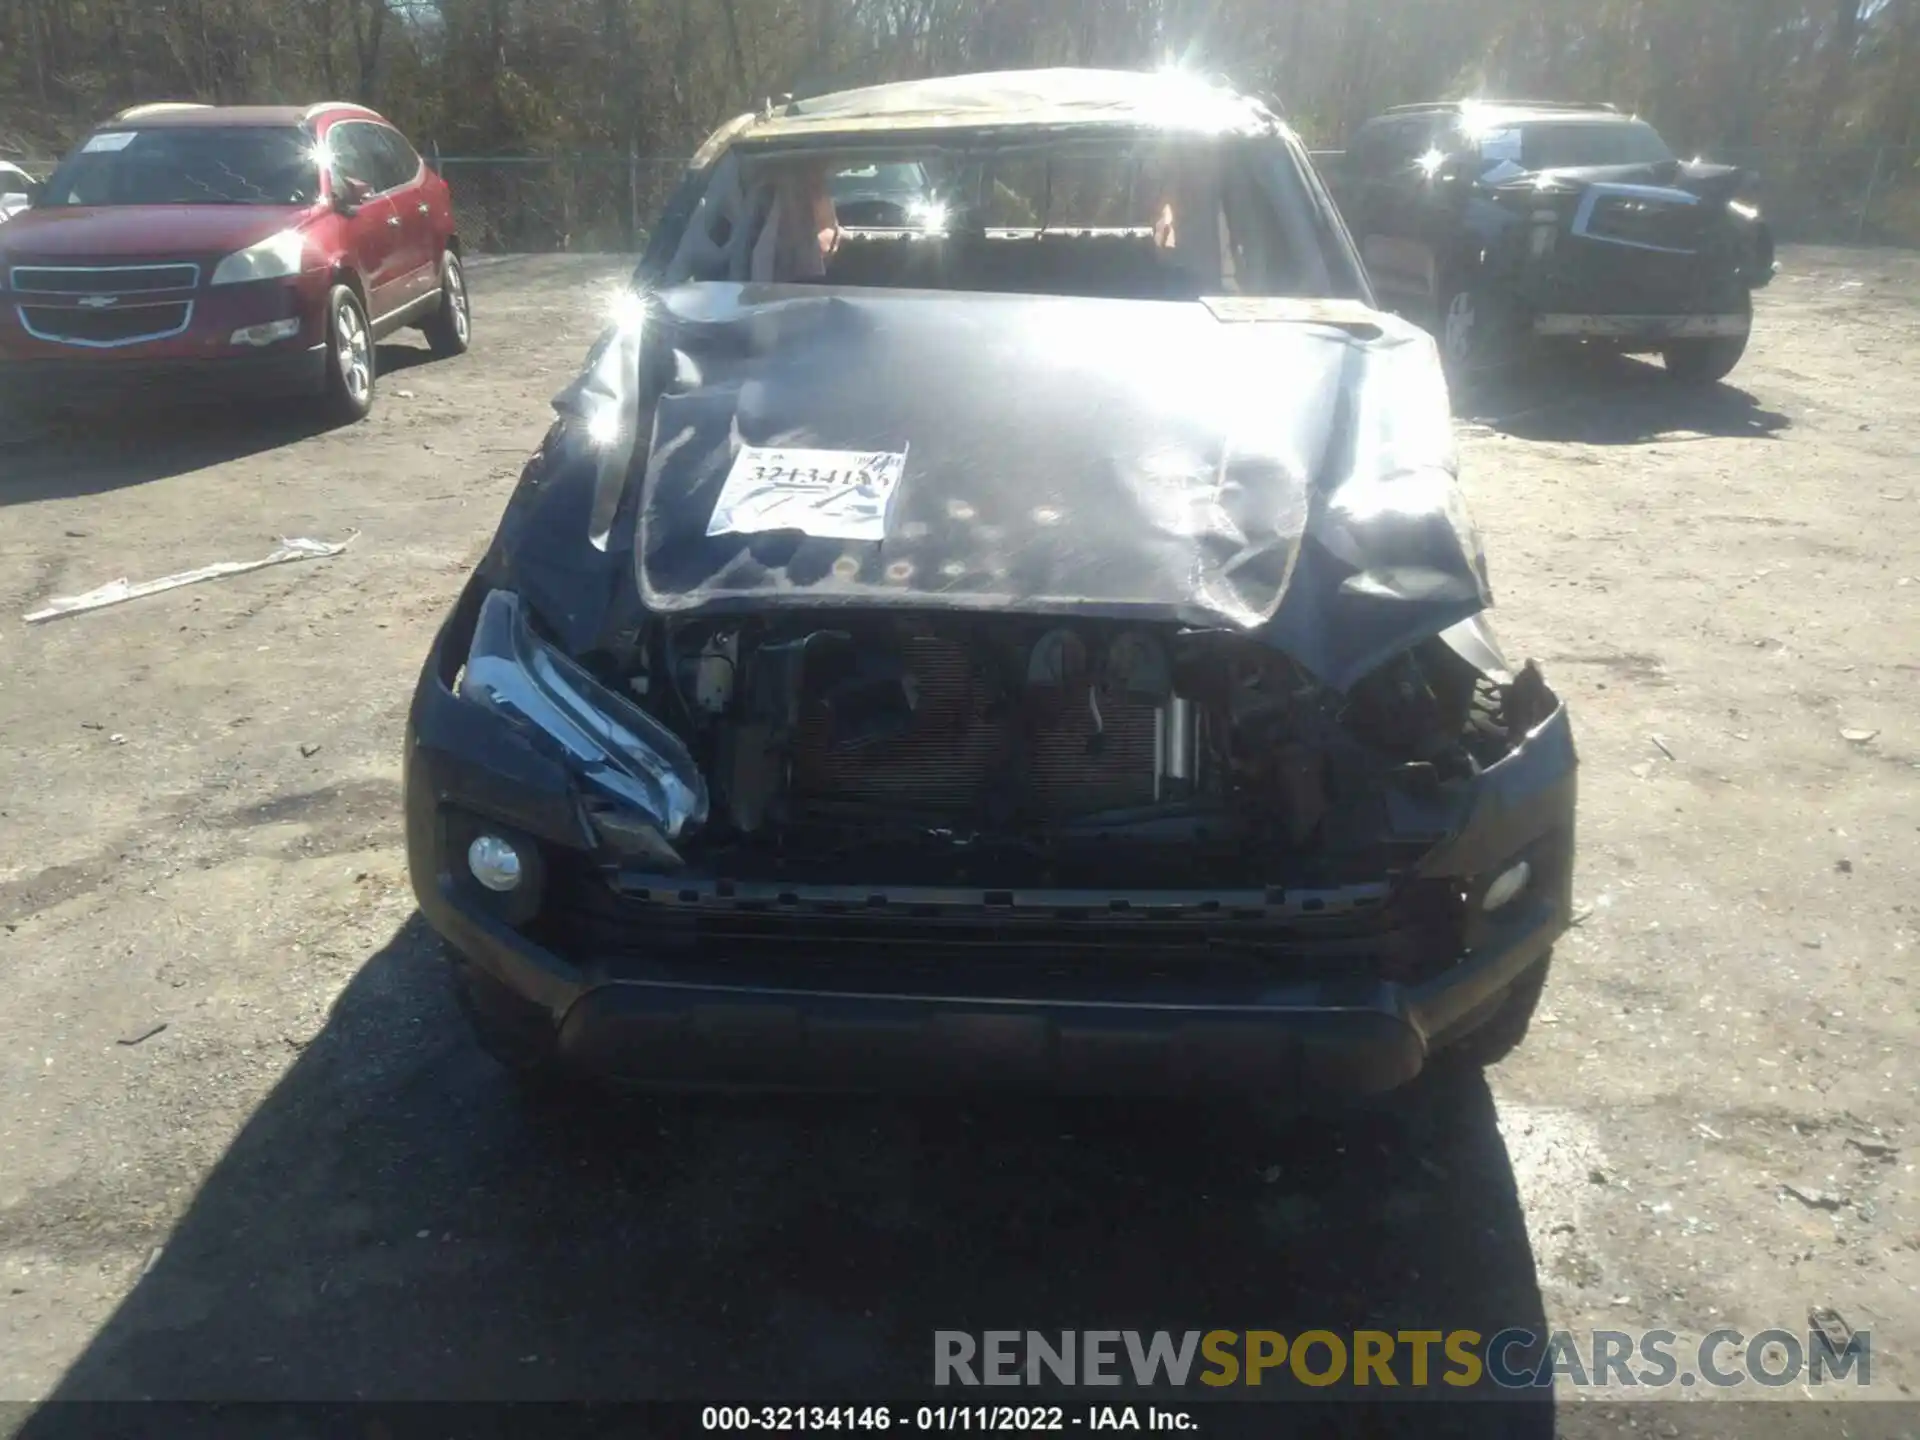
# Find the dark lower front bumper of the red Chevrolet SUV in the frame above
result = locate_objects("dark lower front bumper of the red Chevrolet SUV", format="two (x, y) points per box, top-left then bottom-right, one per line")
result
(0, 344), (326, 409)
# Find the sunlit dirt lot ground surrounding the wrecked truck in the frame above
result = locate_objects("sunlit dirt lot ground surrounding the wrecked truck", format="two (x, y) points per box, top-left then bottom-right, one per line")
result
(0, 252), (1920, 1432)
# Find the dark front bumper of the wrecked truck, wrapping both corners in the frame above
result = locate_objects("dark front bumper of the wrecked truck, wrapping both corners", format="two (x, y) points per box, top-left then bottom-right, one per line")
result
(405, 602), (1574, 1098)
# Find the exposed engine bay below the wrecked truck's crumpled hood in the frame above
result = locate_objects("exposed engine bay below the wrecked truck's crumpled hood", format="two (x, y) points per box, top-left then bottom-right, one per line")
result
(599, 611), (1544, 881)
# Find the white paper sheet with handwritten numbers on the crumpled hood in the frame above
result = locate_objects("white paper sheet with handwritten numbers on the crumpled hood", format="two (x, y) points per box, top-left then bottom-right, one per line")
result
(707, 445), (906, 540)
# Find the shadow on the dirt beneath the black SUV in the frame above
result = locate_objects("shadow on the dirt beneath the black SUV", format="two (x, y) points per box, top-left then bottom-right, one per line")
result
(1455, 353), (1791, 445)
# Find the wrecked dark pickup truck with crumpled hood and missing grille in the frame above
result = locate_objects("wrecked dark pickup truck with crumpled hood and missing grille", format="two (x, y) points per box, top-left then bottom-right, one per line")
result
(405, 71), (1574, 1100)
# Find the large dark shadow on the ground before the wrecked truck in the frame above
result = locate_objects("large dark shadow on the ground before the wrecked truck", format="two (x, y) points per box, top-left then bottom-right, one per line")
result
(23, 916), (1553, 1440)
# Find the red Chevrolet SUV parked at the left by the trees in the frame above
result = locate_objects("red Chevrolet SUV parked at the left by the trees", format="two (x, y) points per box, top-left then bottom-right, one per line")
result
(0, 104), (472, 420)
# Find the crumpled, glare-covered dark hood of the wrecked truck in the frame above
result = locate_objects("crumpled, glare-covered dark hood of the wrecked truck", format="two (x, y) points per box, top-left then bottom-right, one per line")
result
(591, 284), (1490, 687)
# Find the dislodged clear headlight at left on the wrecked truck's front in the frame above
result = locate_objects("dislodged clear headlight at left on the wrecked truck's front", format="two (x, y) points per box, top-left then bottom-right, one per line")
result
(459, 589), (707, 839)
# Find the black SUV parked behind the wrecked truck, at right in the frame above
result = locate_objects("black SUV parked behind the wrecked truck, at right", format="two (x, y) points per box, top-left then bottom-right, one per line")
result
(1342, 102), (1774, 382)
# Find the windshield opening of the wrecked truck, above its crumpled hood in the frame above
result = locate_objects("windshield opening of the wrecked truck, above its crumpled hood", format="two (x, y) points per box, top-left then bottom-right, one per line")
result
(666, 134), (1334, 300)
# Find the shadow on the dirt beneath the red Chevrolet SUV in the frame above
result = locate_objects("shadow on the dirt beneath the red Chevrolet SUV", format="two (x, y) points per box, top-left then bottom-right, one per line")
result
(0, 344), (432, 505)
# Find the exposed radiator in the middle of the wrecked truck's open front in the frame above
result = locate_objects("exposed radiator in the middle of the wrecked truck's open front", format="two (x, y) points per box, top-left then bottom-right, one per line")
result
(793, 636), (1158, 818)
